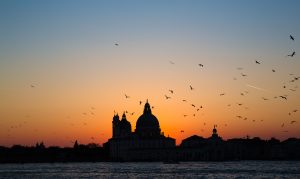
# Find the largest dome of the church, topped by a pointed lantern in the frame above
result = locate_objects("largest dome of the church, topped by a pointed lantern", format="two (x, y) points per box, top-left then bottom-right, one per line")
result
(135, 101), (160, 137)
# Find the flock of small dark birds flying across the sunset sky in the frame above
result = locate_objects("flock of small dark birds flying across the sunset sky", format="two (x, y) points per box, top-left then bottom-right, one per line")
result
(7, 35), (300, 145)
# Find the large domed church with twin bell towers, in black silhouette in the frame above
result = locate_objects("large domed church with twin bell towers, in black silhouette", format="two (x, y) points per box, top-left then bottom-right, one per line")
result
(105, 100), (175, 161)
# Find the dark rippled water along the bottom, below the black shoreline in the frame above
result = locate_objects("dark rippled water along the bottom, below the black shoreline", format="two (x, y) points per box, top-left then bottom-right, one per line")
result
(0, 161), (300, 179)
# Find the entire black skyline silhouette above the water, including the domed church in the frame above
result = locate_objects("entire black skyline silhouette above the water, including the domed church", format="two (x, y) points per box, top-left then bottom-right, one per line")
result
(0, 101), (300, 163)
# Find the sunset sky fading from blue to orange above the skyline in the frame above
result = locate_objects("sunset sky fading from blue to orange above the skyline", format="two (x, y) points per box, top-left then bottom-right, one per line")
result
(0, 0), (300, 146)
